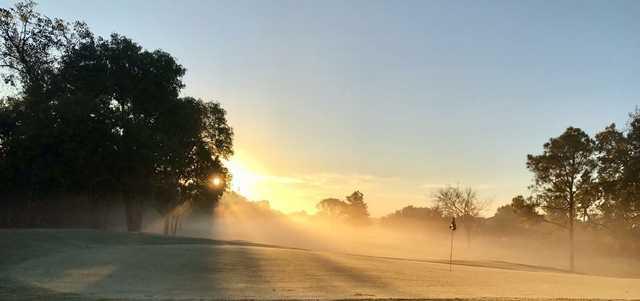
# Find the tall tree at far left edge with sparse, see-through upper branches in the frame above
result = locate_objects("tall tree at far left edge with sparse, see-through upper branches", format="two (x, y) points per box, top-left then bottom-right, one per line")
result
(0, 1), (93, 223)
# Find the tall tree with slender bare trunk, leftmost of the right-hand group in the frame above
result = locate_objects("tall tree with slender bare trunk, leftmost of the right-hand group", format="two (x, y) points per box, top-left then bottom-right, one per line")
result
(527, 127), (595, 271)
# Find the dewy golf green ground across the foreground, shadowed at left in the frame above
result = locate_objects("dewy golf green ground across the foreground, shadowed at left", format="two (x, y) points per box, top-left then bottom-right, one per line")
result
(0, 230), (640, 300)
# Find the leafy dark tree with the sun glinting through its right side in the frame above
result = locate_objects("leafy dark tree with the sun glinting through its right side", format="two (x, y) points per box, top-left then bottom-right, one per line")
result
(153, 97), (233, 234)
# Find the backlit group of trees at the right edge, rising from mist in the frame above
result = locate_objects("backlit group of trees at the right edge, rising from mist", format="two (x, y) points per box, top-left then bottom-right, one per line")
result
(526, 111), (640, 270)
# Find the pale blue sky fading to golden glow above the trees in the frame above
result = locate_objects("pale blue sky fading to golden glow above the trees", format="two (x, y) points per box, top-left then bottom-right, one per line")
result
(11, 0), (640, 216)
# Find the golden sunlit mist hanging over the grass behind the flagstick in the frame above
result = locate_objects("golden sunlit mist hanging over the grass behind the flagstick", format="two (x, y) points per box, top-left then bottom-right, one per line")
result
(142, 193), (640, 278)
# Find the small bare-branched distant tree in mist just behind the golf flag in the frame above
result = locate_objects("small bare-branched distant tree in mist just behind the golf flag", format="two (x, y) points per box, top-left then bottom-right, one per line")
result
(433, 186), (485, 245)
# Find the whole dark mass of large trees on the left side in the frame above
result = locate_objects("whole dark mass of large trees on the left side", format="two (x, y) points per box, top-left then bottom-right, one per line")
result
(0, 1), (233, 232)
